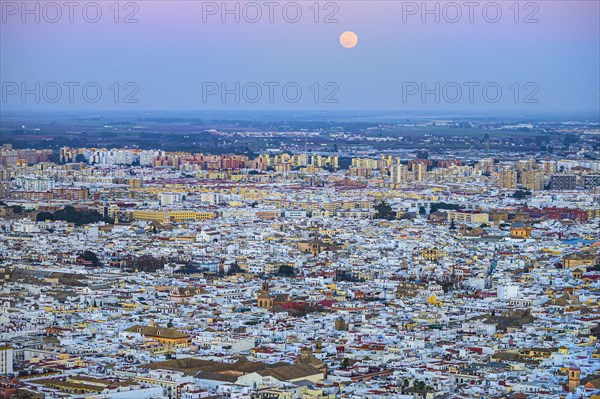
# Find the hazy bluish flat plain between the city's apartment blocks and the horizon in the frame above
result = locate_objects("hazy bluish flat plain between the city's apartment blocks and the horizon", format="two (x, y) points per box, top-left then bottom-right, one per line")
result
(0, 115), (592, 156)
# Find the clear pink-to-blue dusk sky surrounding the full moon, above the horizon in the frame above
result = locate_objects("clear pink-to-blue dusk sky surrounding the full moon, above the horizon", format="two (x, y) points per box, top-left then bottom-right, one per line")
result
(0, 0), (600, 113)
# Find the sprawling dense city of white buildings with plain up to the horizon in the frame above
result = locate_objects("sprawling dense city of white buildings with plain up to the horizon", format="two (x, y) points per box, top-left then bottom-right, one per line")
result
(0, 116), (600, 399)
